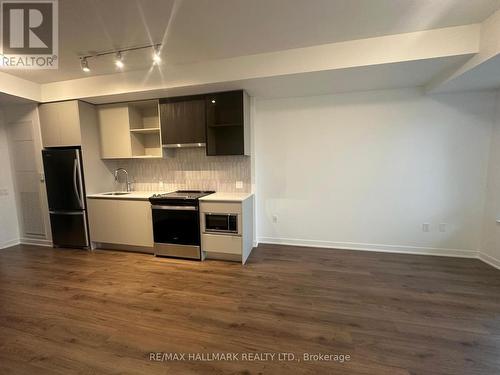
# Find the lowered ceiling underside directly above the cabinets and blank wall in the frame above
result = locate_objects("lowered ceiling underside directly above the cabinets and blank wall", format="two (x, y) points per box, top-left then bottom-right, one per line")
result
(79, 55), (470, 104)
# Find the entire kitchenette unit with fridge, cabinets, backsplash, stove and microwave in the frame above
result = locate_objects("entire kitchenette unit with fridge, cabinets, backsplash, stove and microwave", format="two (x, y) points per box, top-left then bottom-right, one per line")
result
(39, 90), (254, 264)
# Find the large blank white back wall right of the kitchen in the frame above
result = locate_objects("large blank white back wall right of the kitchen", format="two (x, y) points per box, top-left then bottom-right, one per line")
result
(254, 89), (500, 256)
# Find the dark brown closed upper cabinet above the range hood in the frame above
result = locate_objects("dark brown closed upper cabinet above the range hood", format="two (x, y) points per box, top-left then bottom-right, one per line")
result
(160, 95), (206, 147)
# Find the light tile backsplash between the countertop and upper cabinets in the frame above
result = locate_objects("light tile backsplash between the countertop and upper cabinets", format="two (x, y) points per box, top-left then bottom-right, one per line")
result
(106, 148), (252, 192)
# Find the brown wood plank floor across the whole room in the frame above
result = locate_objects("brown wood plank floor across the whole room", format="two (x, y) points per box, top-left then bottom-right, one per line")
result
(0, 245), (500, 375)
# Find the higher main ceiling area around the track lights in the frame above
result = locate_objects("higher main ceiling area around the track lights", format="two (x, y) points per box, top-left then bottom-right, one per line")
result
(4, 0), (500, 83)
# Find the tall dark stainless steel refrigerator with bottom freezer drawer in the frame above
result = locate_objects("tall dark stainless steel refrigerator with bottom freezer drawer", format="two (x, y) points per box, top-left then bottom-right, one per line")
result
(42, 148), (90, 248)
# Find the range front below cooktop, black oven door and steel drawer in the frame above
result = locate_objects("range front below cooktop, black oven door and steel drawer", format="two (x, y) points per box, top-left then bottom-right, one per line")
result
(151, 205), (200, 259)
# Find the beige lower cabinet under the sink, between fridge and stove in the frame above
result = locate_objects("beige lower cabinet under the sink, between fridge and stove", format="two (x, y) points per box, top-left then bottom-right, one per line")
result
(87, 198), (153, 248)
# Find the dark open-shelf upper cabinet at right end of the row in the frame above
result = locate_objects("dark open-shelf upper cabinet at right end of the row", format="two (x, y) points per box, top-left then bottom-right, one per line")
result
(206, 90), (250, 156)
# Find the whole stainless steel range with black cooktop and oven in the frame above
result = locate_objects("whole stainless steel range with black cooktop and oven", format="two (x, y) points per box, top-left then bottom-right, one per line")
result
(149, 190), (215, 260)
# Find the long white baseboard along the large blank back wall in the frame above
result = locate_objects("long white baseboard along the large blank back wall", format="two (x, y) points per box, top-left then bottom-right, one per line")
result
(258, 237), (478, 258)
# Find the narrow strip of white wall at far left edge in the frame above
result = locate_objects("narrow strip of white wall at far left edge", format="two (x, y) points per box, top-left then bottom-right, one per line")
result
(0, 109), (19, 249)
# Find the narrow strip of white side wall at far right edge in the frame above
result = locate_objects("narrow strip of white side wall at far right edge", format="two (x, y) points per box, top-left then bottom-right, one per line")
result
(481, 91), (500, 268)
